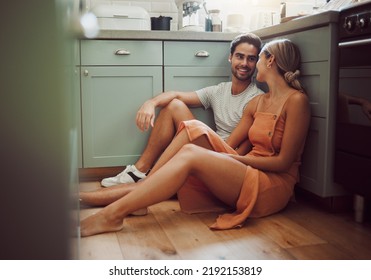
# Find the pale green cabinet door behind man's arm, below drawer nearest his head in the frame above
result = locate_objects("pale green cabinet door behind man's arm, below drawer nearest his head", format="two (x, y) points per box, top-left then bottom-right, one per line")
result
(164, 67), (231, 128)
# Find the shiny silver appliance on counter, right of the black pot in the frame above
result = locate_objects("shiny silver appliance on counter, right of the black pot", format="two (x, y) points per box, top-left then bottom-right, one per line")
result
(176, 0), (206, 31)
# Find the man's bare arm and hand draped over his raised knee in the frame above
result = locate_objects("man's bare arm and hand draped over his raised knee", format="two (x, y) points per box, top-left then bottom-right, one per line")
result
(136, 91), (202, 131)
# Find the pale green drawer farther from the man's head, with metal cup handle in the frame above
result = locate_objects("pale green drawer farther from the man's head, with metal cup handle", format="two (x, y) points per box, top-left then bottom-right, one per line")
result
(81, 40), (162, 65)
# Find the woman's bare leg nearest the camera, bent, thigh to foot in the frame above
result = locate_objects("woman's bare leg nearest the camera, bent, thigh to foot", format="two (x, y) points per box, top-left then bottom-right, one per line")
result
(81, 145), (246, 236)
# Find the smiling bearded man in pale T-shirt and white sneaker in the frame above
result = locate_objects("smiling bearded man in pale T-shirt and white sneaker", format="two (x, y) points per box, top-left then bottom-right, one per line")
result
(101, 33), (263, 187)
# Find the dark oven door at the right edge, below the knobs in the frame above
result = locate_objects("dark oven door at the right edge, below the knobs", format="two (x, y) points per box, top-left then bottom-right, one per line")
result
(334, 39), (371, 198)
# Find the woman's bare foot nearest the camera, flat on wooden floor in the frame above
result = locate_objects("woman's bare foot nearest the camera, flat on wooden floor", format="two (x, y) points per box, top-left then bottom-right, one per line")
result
(80, 211), (124, 237)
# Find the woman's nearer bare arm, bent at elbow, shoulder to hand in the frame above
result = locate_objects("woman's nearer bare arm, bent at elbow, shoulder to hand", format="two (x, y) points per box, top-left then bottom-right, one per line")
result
(230, 93), (310, 172)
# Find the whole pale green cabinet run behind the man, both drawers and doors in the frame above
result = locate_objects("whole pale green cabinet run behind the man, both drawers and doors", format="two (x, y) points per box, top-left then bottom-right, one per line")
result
(81, 40), (230, 168)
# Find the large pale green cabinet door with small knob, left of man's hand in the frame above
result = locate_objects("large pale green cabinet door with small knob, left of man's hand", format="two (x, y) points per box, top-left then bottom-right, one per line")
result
(81, 66), (162, 167)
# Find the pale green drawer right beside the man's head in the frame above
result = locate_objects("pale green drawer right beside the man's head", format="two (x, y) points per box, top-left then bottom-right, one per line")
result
(164, 42), (230, 67)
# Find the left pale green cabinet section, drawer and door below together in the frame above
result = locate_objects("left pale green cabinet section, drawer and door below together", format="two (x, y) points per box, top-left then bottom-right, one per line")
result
(81, 40), (162, 168)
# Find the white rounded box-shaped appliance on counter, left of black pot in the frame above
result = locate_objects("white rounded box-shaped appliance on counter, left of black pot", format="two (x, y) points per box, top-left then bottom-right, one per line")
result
(92, 4), (151, 30)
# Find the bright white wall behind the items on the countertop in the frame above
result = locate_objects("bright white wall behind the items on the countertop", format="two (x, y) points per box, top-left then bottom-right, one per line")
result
(85, 0), (326, 31)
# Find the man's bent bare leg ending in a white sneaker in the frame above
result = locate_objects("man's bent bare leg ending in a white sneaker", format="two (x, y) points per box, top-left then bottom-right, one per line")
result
(102, 99), (194, 187)
